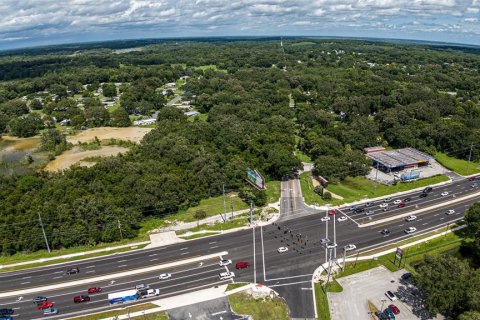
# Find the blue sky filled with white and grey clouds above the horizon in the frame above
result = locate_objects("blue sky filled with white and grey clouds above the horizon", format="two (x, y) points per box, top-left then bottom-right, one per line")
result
(0, 0), (480, 50)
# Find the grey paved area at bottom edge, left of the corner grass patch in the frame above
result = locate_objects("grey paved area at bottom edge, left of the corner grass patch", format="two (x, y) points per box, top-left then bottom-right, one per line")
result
(168, 297), (247, 320)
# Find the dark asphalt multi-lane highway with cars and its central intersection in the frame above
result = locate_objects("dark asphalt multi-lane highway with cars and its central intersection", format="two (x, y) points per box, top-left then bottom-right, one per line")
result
(0, 179), (480, 319)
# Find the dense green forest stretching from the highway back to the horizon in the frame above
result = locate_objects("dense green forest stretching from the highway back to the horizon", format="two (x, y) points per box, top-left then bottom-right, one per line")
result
(0, 39), (480, 255)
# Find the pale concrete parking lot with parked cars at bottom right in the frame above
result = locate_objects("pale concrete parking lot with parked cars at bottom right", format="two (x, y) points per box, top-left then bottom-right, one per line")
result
(328, 267), (441, 320)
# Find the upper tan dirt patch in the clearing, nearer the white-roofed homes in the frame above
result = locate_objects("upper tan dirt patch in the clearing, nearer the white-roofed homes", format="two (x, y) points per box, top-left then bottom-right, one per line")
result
(67, 127), (153, 144)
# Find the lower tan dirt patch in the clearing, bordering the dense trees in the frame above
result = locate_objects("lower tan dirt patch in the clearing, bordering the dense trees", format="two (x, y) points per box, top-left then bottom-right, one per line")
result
(45, 146), (128, 171)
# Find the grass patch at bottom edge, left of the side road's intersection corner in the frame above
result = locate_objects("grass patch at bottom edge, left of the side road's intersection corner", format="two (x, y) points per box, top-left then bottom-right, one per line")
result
(228, 292), (290, 320)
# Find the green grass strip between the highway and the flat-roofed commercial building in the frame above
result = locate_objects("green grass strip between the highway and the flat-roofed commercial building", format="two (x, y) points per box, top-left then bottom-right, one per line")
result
(300, 172), (448, 205)
